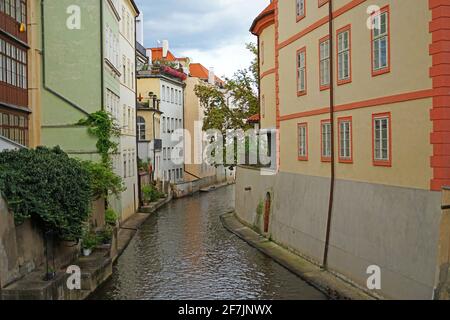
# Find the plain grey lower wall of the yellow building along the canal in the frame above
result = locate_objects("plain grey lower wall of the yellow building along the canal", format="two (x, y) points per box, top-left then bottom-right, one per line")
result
(236, 167), (441, 299)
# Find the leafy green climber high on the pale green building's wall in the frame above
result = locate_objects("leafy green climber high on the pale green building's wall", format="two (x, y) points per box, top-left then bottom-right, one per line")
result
(78, 111), (120, 164)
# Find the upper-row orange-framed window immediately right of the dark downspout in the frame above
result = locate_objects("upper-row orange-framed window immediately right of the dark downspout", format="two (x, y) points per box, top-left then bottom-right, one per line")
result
(337, 26), (352, 85)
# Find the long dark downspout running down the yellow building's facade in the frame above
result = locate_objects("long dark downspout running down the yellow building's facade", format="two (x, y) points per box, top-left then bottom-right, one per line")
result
(322, 0), (336, 269)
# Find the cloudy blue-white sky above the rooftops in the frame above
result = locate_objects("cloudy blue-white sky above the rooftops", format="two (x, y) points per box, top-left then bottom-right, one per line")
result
(135, 0), (270, 76)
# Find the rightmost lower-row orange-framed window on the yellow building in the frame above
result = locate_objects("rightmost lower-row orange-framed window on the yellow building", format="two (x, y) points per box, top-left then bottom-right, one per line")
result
(372, 113), (392, 167)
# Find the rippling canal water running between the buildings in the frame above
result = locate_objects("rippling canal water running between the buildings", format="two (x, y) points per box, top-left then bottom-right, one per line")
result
(91, 186), (325, 300)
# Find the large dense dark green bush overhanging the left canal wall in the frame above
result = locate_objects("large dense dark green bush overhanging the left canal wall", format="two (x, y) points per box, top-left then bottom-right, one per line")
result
(0, 147), (92, 240)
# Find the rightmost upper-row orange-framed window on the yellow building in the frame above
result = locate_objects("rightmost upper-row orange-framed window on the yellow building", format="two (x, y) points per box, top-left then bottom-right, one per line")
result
(372, 6), (390, 76)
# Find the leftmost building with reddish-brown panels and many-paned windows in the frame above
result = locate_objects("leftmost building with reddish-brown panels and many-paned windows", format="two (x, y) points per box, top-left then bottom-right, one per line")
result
(0, 0), (40, 150)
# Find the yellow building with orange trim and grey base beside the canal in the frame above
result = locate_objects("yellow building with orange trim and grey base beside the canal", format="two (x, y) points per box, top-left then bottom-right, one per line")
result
(236, 0), (450, 299)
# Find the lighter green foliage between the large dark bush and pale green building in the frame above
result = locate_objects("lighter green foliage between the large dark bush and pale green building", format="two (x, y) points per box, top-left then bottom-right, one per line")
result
(82, 161), (125, 200)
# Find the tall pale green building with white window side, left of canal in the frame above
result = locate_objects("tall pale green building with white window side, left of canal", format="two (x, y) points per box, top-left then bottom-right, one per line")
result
(33, 0), (138, 220)
